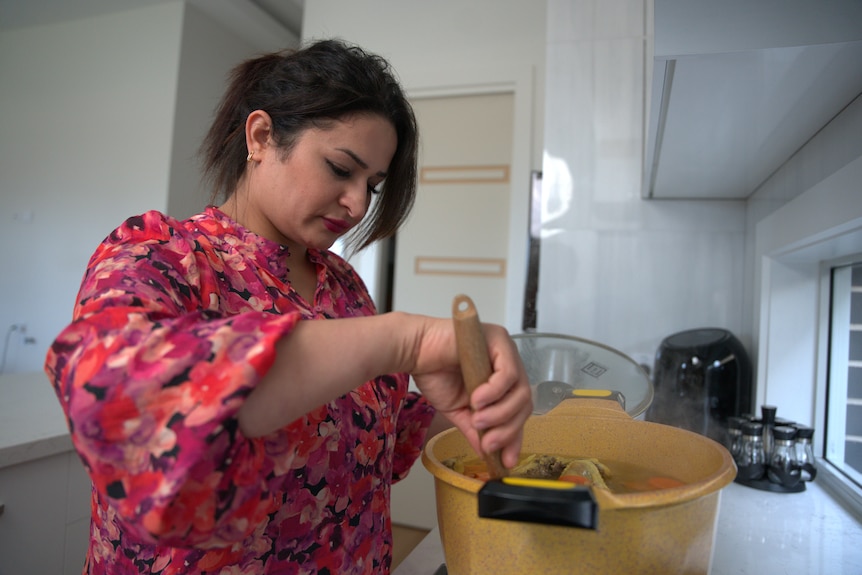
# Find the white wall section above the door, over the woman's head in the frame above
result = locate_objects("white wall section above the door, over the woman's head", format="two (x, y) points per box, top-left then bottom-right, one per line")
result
(302, 0), (545, 104)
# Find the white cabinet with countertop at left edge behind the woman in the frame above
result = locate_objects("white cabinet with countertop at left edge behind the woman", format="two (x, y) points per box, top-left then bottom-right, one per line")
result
(0, 373), (90, 575)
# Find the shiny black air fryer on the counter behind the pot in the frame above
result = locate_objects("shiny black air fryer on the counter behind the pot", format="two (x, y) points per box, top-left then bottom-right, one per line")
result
(646, 328), (752, 445)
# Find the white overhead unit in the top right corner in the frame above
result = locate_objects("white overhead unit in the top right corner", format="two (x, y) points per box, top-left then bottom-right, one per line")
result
(642, 0), (862, 199)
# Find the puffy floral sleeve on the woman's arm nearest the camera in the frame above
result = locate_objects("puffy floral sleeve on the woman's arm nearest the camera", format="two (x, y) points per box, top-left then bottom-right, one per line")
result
(45, 212), (299, 547)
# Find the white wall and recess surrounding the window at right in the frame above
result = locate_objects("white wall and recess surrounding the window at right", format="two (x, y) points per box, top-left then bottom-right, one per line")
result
(746, 97), (862, 428)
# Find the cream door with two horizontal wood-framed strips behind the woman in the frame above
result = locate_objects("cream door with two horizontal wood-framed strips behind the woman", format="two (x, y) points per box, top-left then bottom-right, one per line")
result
(392, 93), (528, 529)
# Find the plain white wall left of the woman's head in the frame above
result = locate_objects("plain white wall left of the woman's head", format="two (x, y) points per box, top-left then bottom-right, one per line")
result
(0, 0), (296, 372)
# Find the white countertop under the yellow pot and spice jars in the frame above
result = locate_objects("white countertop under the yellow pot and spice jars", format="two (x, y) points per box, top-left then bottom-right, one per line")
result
(393, 482), (862, 575)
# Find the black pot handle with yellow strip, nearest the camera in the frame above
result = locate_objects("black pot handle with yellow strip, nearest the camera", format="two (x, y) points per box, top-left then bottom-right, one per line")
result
(477, 477), (599, 529)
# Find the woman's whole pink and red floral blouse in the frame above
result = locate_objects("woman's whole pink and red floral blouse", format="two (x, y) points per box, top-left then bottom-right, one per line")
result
(45, 207), (433, 575)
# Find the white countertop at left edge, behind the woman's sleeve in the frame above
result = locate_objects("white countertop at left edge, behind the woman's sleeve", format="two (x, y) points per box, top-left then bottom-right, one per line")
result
(0, 372), (72, 468)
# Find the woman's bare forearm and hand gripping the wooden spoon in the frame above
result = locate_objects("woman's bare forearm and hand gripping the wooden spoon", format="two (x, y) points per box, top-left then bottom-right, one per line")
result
(239, 312), (532, 474)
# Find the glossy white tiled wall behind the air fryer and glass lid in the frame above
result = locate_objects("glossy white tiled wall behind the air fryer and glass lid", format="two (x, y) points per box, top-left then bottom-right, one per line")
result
(537, 0), (750, 364)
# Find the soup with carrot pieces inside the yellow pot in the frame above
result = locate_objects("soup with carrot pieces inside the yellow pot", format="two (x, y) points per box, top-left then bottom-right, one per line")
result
(443, 453), (684, 493)
